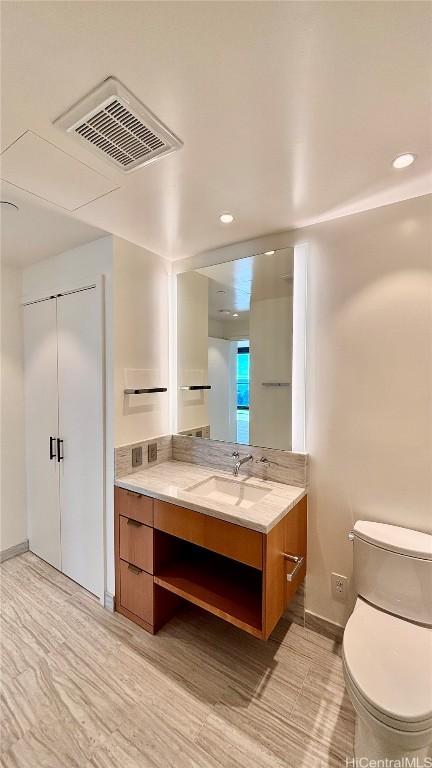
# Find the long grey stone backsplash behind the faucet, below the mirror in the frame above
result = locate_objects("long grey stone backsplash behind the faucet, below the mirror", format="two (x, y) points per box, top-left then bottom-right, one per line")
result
(172, 435), (308, 488)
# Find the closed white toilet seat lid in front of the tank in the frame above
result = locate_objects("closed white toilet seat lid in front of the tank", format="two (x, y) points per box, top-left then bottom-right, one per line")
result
(343, 598), (432, 730)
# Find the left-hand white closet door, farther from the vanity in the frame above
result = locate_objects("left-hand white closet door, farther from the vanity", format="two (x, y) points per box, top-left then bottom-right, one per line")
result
(23, 299), (61, 569)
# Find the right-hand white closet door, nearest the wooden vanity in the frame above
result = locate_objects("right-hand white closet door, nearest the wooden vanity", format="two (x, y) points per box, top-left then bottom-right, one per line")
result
(57, 288), (103, 597)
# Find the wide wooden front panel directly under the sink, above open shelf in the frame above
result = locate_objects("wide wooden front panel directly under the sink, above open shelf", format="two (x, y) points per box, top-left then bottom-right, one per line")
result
(154, 499), (263, 571)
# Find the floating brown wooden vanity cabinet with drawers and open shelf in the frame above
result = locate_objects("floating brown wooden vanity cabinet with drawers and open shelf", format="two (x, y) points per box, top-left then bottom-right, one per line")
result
(115, 487), (307, 640)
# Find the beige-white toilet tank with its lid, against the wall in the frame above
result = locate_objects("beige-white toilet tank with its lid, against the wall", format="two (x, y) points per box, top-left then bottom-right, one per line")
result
(352, 520), (432, 626)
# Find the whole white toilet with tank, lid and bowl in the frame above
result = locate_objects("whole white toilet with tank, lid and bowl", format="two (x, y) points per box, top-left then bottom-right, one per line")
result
(343, 520), (432, 768)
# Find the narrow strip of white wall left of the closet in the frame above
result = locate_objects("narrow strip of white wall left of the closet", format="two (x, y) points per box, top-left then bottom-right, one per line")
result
(0, 264), (27, 551)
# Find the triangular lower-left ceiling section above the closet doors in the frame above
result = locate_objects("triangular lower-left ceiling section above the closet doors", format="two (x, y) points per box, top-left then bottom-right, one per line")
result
(0, 182), (106, 267)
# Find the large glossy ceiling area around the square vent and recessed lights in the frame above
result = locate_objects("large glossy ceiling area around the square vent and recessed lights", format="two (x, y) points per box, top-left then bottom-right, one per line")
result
(1, 1), (432, 259)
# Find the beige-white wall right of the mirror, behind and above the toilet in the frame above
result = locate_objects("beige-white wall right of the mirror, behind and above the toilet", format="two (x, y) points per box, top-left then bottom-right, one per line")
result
(293, 196), (432, 622)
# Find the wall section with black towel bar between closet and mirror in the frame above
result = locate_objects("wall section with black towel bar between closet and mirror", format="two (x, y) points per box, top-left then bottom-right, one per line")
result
(113, 237), (170, 446)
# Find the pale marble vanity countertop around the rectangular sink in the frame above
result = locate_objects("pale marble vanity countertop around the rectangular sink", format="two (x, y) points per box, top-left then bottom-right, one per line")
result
(115, 461), (306, 533)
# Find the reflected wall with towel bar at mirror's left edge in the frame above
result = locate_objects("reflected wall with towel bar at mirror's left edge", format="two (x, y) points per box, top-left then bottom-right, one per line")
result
(177, 272), (209, 432)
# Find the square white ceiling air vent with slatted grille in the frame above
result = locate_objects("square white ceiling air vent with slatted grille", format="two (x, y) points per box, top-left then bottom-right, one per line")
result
(54, 77), (183, 173)
